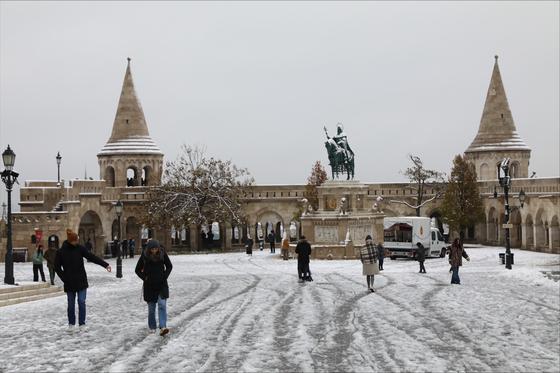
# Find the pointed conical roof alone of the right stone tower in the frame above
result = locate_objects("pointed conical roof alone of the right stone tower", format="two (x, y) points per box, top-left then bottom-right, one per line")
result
(465, 56), (531, 153)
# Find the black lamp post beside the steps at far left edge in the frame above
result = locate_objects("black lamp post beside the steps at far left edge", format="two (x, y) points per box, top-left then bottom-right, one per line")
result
(2, 145), (19, 285)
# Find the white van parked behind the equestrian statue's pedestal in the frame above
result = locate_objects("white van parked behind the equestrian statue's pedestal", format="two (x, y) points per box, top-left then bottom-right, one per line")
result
(383, 216), (447, 260)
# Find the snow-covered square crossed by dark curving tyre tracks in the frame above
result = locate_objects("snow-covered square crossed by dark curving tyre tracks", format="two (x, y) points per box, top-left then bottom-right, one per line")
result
(0, 248), (560, 372)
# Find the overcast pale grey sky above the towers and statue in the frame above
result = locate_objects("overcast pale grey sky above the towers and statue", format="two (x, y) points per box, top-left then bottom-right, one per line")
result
(0, 1), (560, 209)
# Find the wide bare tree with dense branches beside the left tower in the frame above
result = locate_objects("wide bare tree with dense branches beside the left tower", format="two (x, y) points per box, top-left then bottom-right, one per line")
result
(145, 145), (253, 235)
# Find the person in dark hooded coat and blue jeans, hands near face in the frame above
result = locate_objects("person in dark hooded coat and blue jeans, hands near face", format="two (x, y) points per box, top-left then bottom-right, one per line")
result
(135, 240), (173, 336)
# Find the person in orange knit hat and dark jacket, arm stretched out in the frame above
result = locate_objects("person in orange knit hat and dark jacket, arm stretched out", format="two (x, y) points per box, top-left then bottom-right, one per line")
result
(54, 229), (111, 325)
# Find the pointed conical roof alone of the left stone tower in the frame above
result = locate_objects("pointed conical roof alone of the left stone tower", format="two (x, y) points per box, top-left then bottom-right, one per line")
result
(98, 58), (163, 156)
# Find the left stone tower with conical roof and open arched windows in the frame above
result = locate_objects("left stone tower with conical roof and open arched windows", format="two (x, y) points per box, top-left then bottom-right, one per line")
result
(97, 58), (163, 187)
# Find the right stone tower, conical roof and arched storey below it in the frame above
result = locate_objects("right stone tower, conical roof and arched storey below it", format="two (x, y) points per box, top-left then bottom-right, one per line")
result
(465, 56), (531, 180)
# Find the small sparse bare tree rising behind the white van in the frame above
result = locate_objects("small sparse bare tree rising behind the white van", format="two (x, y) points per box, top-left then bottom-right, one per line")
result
(389, 154), (444, 216)
